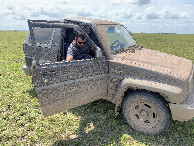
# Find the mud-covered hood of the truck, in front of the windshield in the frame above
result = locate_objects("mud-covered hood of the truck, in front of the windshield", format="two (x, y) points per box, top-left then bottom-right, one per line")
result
(113, 48), (193, 80)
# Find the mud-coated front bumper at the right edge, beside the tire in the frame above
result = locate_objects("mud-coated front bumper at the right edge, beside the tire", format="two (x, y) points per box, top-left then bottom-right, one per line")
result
(169, 76), (194, 121)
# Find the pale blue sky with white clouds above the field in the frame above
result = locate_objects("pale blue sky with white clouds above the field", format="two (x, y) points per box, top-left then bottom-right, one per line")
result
(0, 0), (194, 34)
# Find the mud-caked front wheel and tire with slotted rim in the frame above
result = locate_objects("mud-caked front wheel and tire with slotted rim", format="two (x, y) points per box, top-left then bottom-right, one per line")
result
(122, 92), (171, 135)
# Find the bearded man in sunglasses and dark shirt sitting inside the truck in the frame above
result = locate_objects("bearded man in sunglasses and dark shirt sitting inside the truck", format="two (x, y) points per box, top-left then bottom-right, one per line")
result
(66, 31), (94, 61)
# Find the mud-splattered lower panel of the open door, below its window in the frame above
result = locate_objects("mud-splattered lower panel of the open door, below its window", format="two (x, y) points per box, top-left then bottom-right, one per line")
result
(33, 59), (108, 116)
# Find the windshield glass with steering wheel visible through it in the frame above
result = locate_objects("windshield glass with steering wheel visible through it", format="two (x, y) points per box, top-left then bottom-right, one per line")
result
(107, 26), (136, 52)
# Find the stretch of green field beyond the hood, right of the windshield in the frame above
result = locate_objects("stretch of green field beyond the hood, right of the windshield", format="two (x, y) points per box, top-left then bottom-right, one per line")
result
(133, 34), (194, 63)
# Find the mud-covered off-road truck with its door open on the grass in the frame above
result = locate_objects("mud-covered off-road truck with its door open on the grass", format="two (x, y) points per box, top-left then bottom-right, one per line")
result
(23, 18), (194, 135)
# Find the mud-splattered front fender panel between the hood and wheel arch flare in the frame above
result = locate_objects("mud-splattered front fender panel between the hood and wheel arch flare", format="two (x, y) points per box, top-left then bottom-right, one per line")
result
(108, 55), (187, 103)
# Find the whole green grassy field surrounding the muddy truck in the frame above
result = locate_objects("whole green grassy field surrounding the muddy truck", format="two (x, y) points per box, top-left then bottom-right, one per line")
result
(0, 31), (194, 146)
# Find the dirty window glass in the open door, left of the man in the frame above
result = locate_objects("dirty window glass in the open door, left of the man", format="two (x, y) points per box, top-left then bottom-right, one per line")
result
(31, 27), (62, 63)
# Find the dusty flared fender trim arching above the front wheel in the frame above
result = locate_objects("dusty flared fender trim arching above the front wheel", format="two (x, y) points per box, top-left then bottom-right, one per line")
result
(113, 78), (184, 114)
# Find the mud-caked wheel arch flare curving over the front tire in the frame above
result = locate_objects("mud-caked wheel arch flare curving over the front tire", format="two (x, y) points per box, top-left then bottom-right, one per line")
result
(113, 78), (178, 114)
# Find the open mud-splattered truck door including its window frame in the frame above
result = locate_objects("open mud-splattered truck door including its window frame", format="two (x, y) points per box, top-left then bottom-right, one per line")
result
(28, 20), (108, 117)
